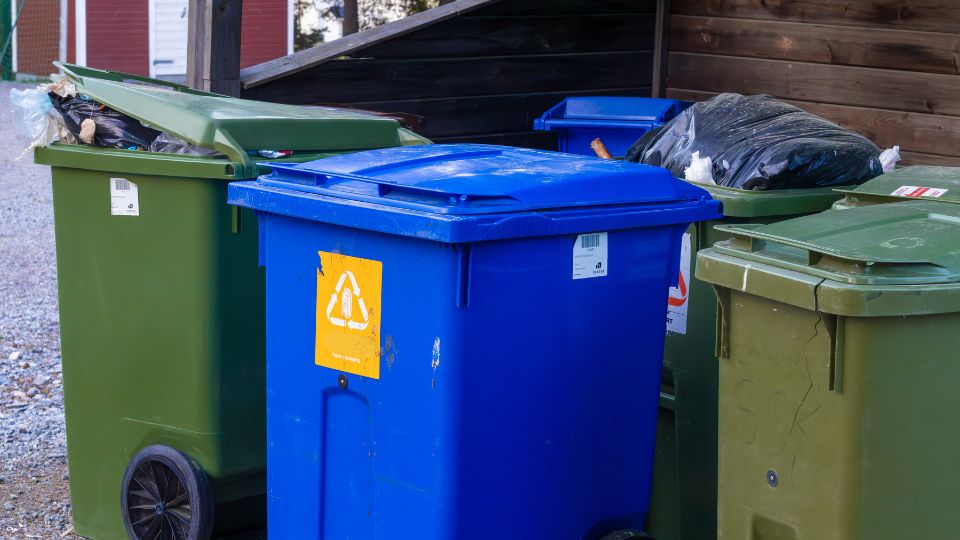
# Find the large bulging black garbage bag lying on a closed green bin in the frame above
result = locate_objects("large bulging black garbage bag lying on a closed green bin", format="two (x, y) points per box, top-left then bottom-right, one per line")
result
(625, 94), (883, 190)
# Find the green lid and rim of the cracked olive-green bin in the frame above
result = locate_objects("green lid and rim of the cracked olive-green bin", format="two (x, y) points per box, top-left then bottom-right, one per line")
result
(697, 200), (960, 316)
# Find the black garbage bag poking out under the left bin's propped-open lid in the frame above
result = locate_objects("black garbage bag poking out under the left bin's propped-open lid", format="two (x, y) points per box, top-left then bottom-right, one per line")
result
(49, 93), (160, 150)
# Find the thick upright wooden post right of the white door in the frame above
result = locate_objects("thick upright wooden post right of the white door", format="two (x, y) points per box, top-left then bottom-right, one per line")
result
(187, 0), (243, 96)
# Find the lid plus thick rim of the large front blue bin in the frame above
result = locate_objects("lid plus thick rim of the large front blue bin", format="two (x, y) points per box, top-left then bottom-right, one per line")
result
(229, 144), (719, 241)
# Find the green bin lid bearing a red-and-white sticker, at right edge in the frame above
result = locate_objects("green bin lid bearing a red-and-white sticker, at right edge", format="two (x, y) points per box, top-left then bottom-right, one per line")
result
(838, 165), (960, 206)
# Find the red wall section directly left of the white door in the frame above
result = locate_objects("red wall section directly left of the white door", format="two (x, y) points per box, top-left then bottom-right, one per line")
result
(87, 0), (150, 76)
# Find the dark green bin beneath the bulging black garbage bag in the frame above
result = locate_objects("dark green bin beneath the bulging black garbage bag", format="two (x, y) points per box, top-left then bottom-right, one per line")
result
(648, 186), (842, 540)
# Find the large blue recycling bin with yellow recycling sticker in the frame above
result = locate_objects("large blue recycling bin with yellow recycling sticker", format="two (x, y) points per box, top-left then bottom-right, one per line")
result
(229, 145), (720, 540)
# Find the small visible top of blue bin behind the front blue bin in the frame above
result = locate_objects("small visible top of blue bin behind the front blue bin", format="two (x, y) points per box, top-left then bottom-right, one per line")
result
(533, 96), (691, 157)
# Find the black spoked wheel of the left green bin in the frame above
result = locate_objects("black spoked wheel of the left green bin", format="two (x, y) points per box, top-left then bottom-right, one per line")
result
(120, 444), (213, 540)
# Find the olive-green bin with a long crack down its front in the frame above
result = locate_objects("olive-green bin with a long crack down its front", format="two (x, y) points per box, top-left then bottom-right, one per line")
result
(697, 200), (960, 540)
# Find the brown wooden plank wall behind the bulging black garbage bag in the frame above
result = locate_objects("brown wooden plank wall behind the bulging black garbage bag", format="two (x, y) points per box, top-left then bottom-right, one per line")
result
(667, 0), (960, 166)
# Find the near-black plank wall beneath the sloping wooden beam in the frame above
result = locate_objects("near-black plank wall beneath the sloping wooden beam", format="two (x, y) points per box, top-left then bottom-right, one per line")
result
(243, 0), (656, 148)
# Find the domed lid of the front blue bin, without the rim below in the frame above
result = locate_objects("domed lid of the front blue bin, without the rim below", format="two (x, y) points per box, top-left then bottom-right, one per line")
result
(251, 144), (684, 215)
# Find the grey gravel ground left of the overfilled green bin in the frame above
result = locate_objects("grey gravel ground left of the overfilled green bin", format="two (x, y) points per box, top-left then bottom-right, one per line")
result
(0, 83), (79, 539)
